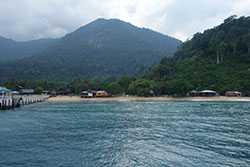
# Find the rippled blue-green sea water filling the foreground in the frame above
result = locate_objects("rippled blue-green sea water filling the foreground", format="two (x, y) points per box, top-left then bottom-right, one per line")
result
(0, 102), (250, 167)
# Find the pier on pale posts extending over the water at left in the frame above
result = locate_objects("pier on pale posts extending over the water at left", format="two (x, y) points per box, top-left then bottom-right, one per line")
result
(0, 87), (49, 110)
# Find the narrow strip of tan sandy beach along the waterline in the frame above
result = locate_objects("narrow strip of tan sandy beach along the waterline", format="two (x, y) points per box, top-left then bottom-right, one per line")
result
(48, 96), (250, 102)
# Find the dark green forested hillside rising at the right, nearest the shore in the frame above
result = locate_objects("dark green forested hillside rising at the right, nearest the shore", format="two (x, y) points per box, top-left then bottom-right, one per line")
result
(134, 16), (250, 95)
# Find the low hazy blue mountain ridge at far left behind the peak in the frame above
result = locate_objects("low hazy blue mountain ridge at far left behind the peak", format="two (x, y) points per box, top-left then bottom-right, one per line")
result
(0, 36), (56, 62)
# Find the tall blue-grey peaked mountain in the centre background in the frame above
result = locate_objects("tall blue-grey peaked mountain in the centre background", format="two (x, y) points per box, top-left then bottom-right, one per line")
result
(0, 19), (181, 80)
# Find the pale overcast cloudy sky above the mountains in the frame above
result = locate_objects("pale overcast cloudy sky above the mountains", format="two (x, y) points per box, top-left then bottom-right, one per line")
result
(0, 0), (250, 41)
